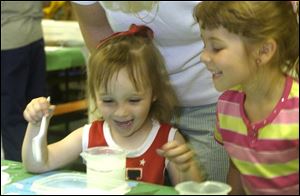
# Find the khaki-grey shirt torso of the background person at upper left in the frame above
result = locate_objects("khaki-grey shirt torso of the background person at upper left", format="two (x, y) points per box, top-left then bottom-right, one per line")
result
(1, 1), (43, 50)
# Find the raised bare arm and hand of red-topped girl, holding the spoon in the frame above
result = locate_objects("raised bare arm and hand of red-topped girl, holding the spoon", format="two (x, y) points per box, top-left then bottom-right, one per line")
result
(22, 97), (82, 173)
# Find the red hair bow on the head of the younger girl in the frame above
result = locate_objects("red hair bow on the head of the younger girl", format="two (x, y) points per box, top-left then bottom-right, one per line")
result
(96, 24), (154, 49)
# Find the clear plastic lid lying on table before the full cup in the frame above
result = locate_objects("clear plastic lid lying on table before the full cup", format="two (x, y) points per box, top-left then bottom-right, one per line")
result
(31, 172), (130, 195)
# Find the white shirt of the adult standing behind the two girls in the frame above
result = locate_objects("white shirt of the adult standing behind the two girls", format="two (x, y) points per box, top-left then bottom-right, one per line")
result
(74, 1), (219, 107)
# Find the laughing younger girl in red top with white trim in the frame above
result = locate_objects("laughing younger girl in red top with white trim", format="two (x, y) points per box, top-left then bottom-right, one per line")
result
(22, 25), (201, 184)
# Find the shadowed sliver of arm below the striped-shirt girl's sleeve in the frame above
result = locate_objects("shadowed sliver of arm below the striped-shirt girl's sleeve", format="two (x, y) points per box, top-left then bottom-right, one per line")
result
(227, 160), (245, 195)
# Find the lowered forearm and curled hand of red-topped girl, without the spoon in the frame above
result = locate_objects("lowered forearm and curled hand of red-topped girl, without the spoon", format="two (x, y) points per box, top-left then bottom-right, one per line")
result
(158, 131), (203, 185)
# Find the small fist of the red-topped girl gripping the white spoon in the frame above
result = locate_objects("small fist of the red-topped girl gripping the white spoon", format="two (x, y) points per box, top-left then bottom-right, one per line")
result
(23, 97), (55, 125)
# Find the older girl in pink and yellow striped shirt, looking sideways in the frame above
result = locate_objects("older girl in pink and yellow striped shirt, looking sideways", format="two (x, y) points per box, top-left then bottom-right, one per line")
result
(194, 1), (299, 195)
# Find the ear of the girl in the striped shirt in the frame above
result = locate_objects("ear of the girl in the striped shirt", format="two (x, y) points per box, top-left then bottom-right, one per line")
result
(258, 39), (277, 65)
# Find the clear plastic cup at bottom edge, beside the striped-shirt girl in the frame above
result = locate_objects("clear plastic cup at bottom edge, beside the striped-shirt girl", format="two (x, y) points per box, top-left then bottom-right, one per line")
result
(175, 181), (231, 195)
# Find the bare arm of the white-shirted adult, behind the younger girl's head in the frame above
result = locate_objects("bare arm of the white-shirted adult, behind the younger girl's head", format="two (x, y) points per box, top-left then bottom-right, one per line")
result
(72, 2), (113, 52)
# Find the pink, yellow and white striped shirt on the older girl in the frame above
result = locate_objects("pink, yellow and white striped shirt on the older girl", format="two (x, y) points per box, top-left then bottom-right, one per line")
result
(215, 77), (299, 195)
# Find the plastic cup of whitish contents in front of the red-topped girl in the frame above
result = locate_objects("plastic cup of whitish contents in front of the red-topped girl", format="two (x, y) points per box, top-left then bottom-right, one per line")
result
(80, 147), (126, 191)
